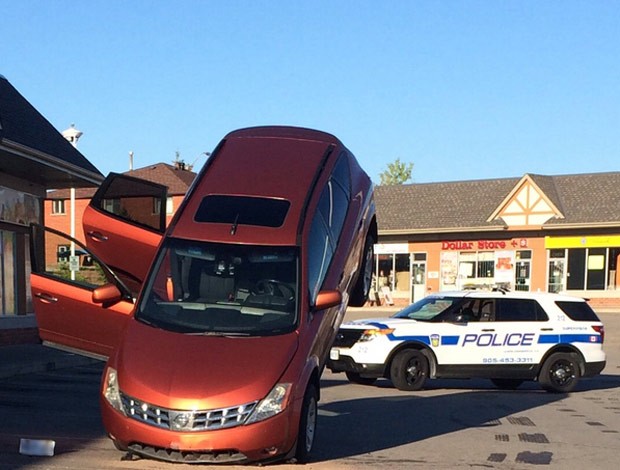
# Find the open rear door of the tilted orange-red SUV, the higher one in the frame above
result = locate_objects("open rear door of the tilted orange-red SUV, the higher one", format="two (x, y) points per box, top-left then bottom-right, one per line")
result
(82, 173), (166, 296)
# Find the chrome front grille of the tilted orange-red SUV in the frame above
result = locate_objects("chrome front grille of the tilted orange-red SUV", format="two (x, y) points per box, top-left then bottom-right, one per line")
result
(121, 393), (258, 431)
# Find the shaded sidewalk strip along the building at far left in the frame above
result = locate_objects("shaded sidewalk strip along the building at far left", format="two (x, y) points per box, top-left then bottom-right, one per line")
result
(0, 344), (100, 380)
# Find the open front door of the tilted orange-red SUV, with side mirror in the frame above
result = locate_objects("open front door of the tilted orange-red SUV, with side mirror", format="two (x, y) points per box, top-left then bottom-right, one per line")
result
(30, 225), (134, 359)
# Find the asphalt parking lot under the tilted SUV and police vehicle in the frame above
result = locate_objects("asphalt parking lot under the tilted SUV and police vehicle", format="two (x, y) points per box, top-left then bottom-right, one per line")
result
(0, 308), (620, 470)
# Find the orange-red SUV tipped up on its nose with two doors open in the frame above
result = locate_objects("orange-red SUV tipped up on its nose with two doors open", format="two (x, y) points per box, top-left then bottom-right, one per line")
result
(31, 127), (377, 463)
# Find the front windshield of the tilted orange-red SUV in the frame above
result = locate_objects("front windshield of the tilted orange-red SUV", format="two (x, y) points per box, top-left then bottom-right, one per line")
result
(136, 238), (299, 336)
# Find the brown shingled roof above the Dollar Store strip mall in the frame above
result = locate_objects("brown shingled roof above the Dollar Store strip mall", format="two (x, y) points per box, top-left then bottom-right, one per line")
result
(376, 172), (620, 233)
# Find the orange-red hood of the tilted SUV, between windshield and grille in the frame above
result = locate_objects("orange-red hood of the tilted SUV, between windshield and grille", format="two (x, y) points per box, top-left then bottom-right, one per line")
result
(116, 320), (298, 410)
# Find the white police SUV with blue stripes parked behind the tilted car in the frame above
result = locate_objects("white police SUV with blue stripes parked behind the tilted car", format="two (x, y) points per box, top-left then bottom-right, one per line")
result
(327, 291), (606, 393)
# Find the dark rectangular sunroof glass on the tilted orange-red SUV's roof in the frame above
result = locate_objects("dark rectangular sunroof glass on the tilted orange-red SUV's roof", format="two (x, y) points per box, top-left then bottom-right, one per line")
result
(194, 195), (291, 227)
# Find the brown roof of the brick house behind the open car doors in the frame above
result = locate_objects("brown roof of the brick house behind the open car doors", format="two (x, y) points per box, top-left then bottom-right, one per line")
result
(47, 163), (196, 199)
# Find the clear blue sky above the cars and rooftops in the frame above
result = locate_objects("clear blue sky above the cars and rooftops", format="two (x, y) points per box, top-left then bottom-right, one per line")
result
(0, 0), (620, 183)
